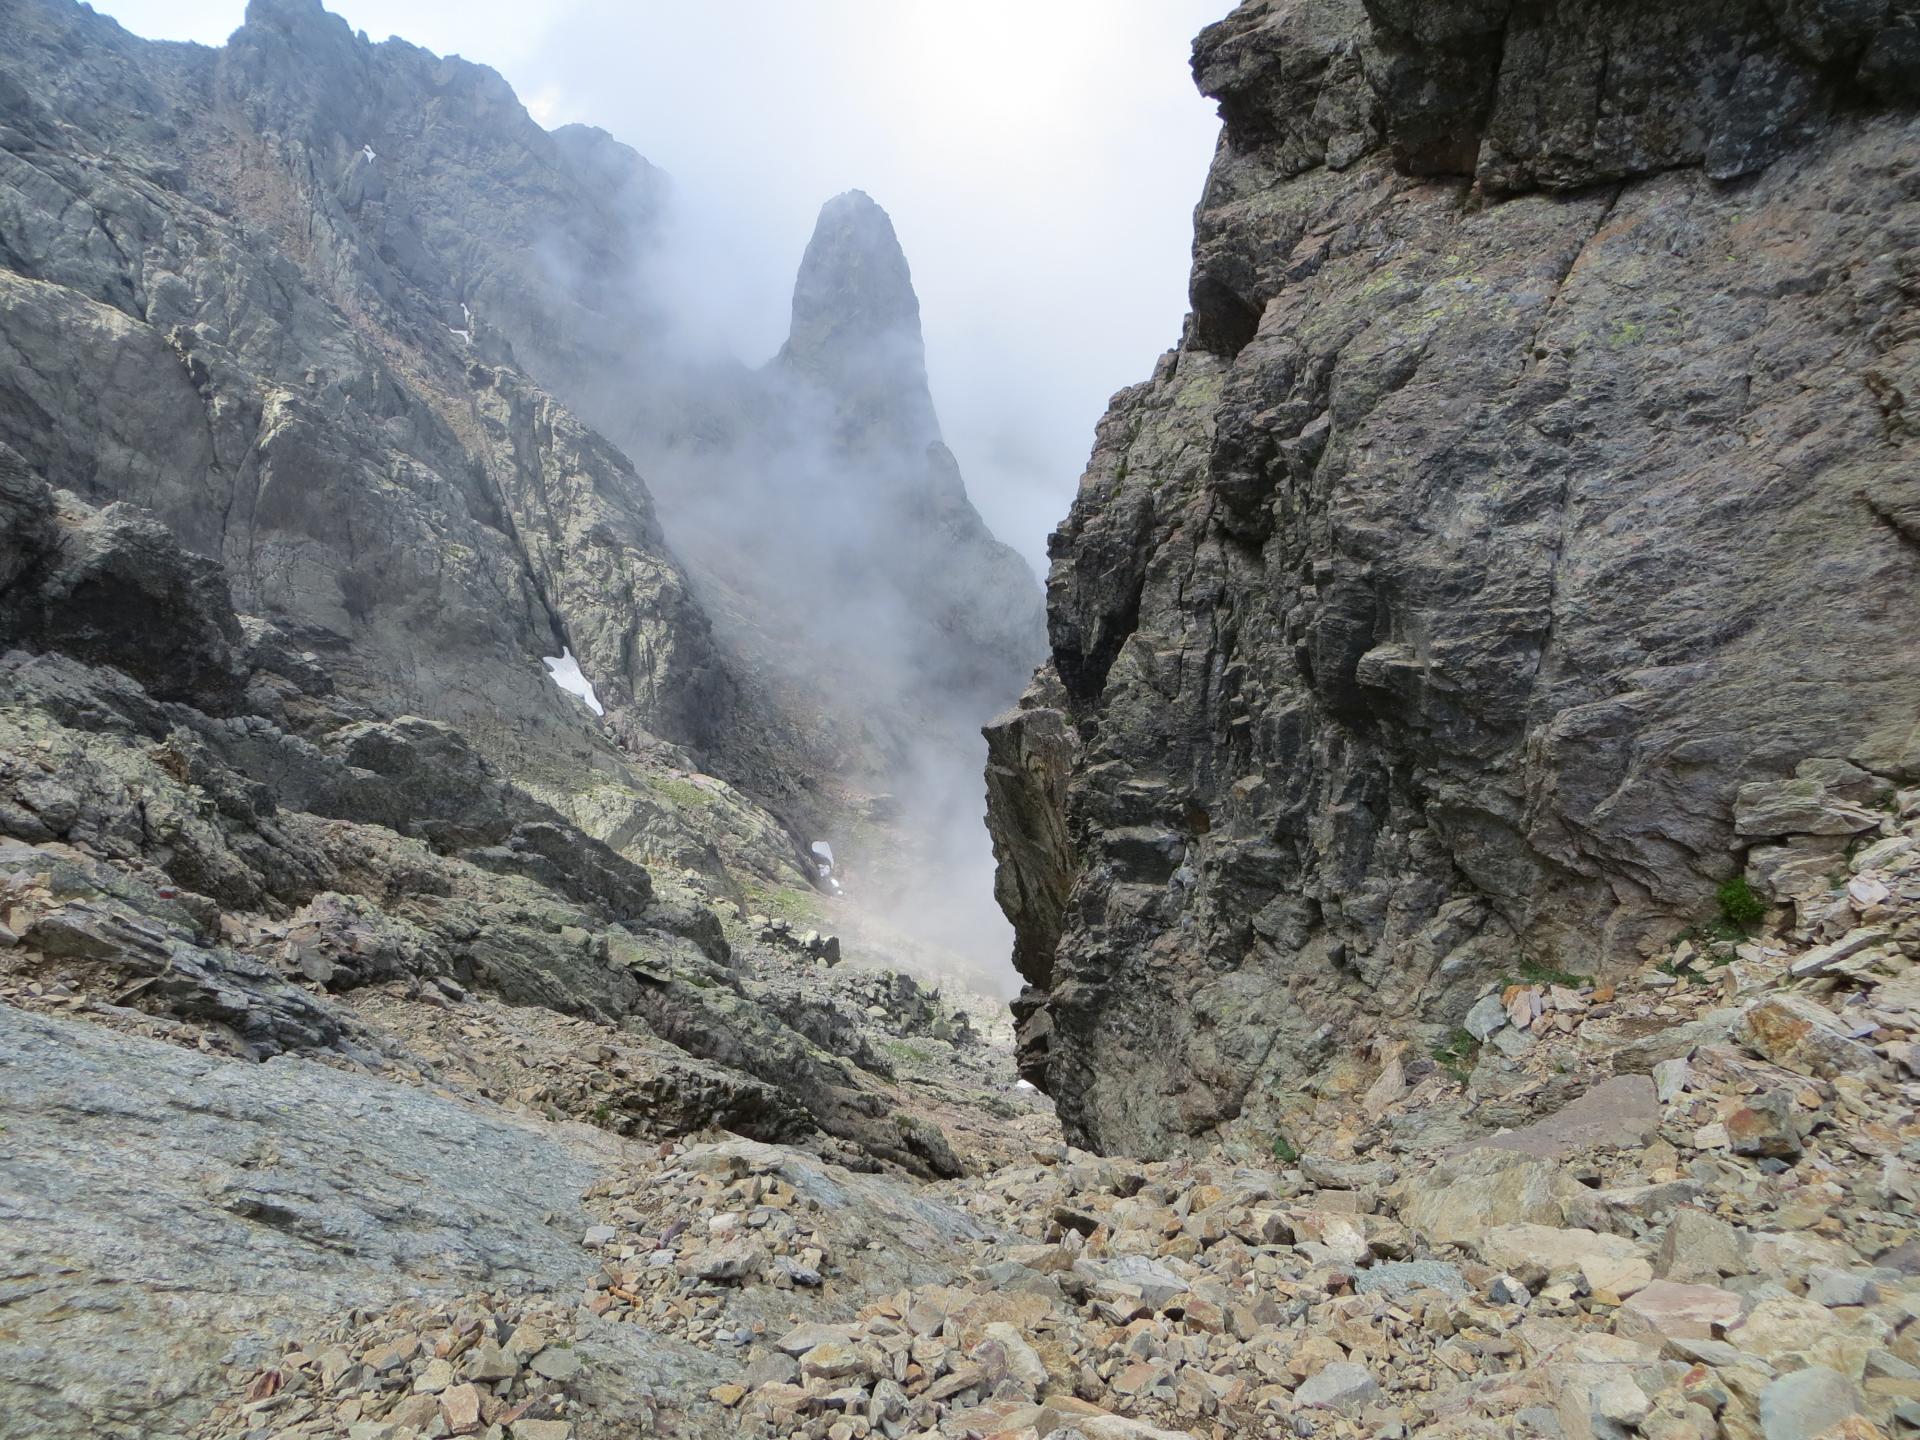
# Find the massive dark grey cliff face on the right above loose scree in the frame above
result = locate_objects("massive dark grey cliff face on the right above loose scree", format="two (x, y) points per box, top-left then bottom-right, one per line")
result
(989, 0), (1920, 1152)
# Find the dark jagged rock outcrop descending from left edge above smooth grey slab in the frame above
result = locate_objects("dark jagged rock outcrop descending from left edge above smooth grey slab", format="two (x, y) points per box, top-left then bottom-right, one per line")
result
(0, 468), (956, 1169)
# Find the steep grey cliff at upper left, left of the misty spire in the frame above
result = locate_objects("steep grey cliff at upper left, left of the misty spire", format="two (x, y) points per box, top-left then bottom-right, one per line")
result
(0, 2), (733, 791)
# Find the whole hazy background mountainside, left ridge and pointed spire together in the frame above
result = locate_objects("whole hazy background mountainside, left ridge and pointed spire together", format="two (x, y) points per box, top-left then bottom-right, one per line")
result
(0, 0), (1041, 990)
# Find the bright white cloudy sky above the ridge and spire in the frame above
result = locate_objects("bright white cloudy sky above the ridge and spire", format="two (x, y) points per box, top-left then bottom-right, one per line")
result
(94, 0), (1231, 566)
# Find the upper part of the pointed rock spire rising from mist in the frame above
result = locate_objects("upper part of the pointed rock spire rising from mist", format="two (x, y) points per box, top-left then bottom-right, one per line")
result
(780, 190), (941, 449)
